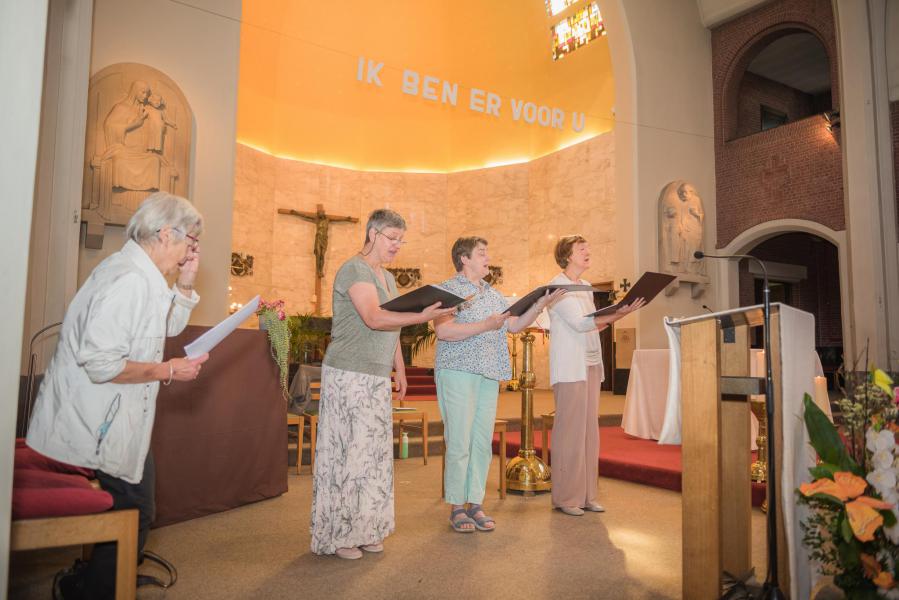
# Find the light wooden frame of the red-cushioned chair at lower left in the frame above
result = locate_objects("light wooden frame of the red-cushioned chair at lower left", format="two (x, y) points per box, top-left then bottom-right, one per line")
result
(10, 509), (137, 600)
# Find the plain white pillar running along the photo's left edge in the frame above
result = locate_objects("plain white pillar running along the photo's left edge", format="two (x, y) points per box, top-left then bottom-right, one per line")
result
(0, 0), (47, 595)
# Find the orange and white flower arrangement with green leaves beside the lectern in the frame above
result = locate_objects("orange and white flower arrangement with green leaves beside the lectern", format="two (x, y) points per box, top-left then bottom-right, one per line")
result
(798, 368), (899, 600)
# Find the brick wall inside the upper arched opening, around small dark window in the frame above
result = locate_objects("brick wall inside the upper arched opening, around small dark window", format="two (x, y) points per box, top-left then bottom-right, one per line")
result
(736, 71), (815, 137)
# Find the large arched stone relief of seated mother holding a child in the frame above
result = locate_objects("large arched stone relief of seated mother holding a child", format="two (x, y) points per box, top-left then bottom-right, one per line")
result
(81, 63), (193, 248)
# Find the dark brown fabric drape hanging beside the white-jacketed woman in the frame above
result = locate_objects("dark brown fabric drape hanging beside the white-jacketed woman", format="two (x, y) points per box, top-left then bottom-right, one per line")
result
(151, 326), (287, 527)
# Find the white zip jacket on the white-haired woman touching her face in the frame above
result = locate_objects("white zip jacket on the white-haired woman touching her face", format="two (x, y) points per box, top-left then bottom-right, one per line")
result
(27, 240), (199, 483)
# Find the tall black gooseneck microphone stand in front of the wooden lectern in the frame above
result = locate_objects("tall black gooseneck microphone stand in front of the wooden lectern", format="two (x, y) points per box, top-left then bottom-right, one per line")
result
(693, 251), (786, 600)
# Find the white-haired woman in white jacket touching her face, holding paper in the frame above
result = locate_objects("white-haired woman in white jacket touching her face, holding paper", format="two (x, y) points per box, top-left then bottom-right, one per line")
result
(27, 192), (208, 599)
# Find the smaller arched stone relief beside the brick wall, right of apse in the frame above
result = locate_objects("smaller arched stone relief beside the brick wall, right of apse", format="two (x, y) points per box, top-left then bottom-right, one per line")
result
(659, 180), (705, 275)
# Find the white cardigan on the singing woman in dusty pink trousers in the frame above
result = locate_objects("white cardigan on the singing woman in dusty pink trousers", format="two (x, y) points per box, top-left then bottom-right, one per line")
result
(549, 273), (602, 386)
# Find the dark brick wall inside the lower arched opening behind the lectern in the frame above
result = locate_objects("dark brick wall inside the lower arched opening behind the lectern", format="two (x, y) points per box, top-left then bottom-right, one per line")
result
(740, 233), (843, 348)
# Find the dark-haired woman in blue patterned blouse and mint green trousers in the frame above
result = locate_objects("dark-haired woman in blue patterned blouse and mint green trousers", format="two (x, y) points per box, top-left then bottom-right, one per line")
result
(434, 237), (563, 533)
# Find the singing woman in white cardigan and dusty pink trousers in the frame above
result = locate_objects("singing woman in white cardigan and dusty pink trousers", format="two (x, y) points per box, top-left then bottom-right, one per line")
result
(549, 235), (644, 516)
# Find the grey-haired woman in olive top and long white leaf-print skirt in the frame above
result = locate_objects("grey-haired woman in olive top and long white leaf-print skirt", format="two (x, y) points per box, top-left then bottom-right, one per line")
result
(311, 208), (455, 560)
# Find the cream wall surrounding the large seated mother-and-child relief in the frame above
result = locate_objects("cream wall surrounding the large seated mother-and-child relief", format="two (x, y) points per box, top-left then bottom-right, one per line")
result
(78, 0), (241, 325)
